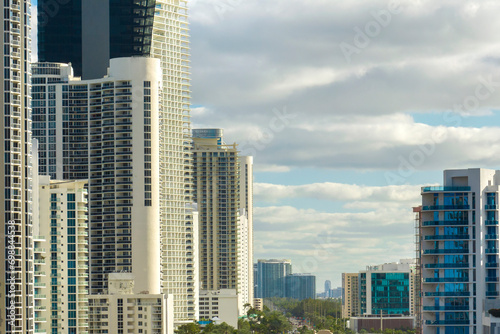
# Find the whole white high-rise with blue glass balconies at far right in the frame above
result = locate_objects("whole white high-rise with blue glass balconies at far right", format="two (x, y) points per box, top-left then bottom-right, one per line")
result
(420, 169), (500, 334)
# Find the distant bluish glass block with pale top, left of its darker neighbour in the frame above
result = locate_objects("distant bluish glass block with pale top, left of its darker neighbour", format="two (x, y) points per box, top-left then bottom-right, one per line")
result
(255, 260), (292, 298)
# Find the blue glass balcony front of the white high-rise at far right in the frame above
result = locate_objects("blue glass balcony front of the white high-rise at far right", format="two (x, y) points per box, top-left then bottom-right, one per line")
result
(421, 187), (476, 334)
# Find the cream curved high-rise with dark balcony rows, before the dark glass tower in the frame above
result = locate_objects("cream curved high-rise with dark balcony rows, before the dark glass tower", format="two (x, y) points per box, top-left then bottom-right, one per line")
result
(33, 58), (168, 294)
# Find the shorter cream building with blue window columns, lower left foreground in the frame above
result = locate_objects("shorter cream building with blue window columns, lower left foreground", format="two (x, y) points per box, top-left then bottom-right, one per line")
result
(33, 176), (89, 334)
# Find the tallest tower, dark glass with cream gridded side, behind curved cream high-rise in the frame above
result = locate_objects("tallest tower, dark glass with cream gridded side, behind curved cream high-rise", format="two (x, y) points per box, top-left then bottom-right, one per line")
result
(38, 0), (197, 321)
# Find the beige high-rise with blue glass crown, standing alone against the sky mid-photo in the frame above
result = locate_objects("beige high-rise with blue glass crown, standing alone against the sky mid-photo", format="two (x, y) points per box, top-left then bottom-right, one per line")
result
(193, 129), (253, 310)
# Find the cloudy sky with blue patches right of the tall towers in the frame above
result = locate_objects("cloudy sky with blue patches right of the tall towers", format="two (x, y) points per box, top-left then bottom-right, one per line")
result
(191, 0), (500, 291)
